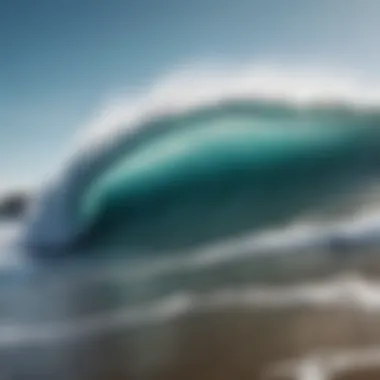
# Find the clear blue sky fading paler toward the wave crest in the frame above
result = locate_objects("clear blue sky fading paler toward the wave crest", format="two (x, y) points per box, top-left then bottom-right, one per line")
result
(0, 0), (380, 191)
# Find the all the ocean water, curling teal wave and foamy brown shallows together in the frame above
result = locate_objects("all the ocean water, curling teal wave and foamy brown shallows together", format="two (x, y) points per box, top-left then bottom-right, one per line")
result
(0, 70), (380, 380)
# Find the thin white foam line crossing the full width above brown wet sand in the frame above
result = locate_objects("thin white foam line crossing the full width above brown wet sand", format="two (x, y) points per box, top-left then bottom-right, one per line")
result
(0, 277), (380, 347)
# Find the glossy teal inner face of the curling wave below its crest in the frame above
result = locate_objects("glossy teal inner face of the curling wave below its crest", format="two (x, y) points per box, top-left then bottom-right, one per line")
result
(80, 107), (378, 250)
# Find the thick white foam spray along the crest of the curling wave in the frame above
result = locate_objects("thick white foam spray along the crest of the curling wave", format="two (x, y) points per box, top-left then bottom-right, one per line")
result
(81, 64), (380, 148)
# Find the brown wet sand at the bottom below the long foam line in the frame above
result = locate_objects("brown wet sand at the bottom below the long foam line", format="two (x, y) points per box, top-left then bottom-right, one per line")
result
(1, 310), (380, 380)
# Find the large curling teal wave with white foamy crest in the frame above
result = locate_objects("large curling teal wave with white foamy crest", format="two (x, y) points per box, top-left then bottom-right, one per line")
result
(21, 66), (380, 251)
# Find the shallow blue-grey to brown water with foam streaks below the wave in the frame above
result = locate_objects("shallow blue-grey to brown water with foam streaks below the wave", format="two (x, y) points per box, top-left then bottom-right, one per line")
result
(0, 235), (380, 380)
